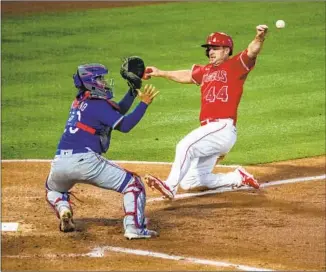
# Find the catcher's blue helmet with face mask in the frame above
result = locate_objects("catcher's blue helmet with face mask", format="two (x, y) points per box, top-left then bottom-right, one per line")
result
(73, 63), (114, 99)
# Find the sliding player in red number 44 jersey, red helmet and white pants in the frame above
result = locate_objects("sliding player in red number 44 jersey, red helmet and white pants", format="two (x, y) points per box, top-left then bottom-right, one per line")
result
(145, 25), (268, 199)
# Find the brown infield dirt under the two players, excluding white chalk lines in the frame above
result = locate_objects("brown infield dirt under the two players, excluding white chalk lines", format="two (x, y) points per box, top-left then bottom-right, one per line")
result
(2, 156), (326, 271)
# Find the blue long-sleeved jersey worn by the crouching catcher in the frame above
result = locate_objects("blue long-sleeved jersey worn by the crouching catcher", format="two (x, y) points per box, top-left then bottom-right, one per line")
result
(58, 93), (147, 154)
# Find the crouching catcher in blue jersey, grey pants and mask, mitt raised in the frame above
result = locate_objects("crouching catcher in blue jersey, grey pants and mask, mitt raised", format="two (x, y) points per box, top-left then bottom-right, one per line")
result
(46, 57), (158, 239)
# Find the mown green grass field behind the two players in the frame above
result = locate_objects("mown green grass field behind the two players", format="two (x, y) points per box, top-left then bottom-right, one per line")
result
(1, 2), (325, 164)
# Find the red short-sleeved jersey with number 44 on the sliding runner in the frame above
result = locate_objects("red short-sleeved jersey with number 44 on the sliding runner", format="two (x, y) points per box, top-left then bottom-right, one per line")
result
(192, 50), (255, 123)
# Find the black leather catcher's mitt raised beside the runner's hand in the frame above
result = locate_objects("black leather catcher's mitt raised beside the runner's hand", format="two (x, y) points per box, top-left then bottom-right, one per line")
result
(120, 56), (145, 94)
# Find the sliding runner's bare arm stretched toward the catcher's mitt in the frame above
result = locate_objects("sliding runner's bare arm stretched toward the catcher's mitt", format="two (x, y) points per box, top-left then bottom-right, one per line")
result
(146, 66), (193, 84)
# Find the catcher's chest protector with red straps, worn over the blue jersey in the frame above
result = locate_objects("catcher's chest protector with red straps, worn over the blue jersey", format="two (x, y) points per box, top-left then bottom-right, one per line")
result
(73, 91), (120, 153)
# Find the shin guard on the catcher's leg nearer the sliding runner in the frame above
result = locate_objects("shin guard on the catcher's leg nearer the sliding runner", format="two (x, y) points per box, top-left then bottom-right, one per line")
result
(123, 175), (146, 228)
